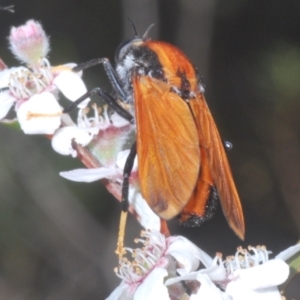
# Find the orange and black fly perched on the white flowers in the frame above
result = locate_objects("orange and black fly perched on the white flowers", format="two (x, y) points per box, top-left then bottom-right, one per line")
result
(67, 28), (245, 239)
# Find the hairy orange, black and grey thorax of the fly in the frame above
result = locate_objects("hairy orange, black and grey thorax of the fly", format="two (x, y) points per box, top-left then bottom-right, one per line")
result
(116, 41), (203, 103)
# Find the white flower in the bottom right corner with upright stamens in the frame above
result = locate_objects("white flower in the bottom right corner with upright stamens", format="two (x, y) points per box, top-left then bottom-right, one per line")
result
(165, 245), (300, 300)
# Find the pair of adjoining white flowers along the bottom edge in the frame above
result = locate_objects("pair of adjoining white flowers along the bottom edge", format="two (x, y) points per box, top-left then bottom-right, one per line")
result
(107, 230), (300, 300)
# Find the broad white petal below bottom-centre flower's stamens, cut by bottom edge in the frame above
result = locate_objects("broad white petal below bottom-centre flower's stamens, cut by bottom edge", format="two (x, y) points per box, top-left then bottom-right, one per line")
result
(133, 268), (170, 300)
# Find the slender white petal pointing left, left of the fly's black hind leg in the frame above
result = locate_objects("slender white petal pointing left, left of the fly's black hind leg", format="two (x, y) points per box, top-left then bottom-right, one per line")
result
(59, 168), (120, 182)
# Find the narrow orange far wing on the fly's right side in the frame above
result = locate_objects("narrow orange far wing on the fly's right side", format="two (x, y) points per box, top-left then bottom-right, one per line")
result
(189, 93), (245, 239)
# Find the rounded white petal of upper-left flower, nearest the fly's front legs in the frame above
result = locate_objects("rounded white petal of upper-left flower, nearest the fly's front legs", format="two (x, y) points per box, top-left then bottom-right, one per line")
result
(53, 71), (90, 108)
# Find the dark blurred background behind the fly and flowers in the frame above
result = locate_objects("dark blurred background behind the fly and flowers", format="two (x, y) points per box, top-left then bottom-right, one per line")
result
(0, 0), (300, 300)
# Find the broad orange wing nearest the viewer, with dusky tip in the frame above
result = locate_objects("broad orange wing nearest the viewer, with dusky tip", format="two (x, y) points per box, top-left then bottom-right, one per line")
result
(133, 76), (200, 219)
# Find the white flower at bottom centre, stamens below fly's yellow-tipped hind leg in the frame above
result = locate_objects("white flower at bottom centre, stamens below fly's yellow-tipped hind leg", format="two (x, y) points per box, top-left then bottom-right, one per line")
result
(107, 230), (204, 300)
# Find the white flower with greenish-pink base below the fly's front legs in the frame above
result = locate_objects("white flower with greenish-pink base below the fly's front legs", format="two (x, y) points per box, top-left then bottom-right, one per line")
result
(52, 105), (134, 161)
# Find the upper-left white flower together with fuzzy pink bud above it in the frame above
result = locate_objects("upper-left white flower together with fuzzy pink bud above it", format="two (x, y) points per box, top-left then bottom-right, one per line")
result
(0, 20), (89, 134)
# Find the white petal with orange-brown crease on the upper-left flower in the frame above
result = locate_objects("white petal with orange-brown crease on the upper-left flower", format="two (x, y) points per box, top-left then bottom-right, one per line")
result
(17, 92), (62, 134)
